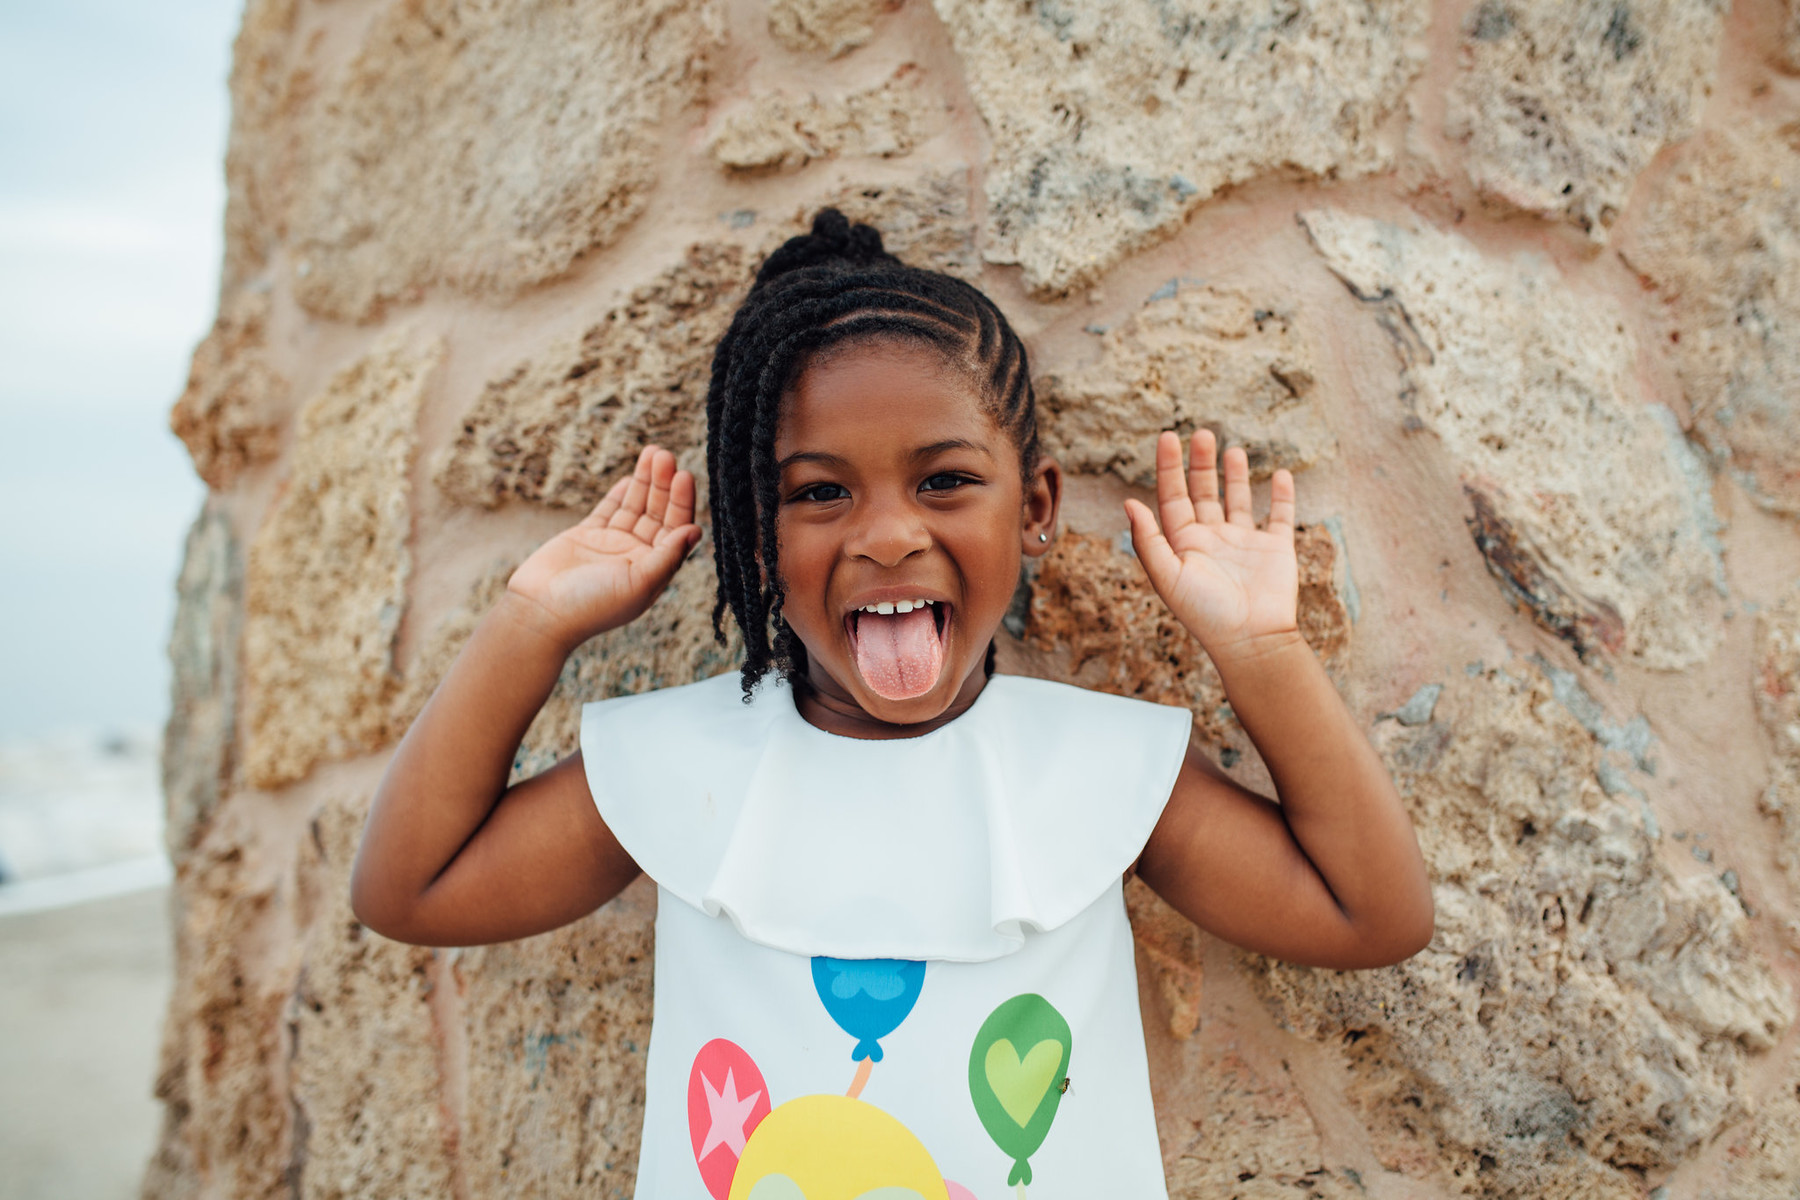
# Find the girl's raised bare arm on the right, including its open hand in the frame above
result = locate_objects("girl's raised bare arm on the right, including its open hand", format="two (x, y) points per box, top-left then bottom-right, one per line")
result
(1125, 430), (1433, 968)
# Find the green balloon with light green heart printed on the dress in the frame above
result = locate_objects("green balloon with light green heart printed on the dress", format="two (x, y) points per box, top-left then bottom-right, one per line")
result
(968, 991), (1073, 1187)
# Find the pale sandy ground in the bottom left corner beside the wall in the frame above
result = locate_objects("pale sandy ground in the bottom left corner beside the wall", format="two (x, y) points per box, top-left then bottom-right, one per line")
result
(0, 887), (171, 1200)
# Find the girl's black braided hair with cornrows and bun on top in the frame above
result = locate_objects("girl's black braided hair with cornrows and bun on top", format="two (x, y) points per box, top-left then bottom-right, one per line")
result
(706, 209), (1037, 700)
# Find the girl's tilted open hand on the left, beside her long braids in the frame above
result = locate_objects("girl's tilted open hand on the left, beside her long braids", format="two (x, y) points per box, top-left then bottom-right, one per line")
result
(506, 446), (700, 648)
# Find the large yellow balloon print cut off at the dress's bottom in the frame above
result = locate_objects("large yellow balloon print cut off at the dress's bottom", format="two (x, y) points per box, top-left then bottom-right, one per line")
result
(729, 1096), (950, 1200)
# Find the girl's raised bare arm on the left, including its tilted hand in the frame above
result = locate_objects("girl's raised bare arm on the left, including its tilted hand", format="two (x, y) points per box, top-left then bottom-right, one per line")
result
(351, 446), (700, 946)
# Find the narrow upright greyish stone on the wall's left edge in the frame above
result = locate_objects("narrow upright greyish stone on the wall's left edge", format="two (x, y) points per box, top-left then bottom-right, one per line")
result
(162, 502), (243, 865)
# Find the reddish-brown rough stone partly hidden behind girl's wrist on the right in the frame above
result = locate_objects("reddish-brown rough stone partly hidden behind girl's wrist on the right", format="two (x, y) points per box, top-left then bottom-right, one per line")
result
(1024, 525), (1350, 766)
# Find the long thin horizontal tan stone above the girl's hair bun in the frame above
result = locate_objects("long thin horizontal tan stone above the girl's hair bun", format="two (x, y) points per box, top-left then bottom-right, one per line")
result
(709, 63), (945, 171)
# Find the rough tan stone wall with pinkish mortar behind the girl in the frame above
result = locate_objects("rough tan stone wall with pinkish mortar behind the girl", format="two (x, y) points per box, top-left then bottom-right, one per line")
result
(144, 0), (1800, 1200)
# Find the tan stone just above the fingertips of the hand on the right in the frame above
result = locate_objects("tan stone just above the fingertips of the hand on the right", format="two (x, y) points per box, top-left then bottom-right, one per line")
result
(1037, 279), (1336, 488)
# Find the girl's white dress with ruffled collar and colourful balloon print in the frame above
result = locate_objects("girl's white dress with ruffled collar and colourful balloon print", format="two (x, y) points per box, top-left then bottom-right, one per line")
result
(581, 673), (1190, 1200)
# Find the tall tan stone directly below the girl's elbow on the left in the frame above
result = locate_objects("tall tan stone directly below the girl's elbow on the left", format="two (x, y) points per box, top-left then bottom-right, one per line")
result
(288, 797), (454, 1200)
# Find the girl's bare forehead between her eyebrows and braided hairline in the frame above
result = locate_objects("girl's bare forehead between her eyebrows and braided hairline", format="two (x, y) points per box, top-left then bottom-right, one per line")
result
(776, 342), (1004, 461)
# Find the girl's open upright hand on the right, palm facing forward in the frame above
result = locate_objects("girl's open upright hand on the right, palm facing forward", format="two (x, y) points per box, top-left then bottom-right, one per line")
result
(1125, 430), (1300, 660)
